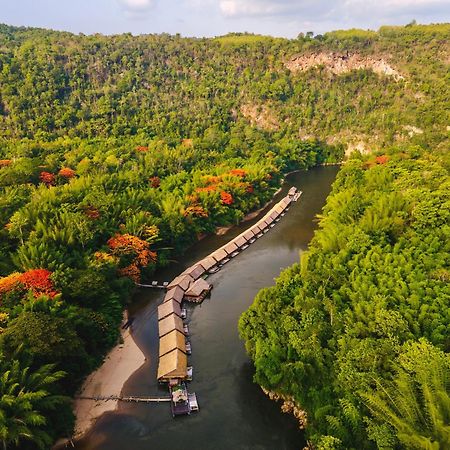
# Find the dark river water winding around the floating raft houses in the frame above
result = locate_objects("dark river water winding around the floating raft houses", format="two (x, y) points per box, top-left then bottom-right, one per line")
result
(76, 166), (338, 450)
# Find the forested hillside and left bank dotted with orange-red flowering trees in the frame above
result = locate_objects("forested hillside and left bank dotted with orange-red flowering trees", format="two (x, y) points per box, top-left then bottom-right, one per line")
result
(0, 24), (450, 449)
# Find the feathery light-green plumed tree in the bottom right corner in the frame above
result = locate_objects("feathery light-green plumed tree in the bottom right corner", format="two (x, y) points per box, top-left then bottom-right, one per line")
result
(361, 340), (450, 450)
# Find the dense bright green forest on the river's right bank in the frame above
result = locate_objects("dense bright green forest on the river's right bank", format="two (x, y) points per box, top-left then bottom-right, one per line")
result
(239, 149), (450, 450)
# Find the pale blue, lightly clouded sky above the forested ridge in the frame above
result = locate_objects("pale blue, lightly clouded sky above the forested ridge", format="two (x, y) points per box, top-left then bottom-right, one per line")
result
(0, 0), (450, 38)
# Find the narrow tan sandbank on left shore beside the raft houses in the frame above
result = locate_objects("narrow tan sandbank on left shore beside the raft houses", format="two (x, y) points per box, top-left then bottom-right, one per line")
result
(74, 324), (145, 438)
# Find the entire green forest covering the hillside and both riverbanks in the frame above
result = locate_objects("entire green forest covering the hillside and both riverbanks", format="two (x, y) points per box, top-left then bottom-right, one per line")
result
(0, 24), (450, 449)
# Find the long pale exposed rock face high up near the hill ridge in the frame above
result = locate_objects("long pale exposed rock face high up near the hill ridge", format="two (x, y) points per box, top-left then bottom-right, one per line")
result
(285, 52), (404, 81)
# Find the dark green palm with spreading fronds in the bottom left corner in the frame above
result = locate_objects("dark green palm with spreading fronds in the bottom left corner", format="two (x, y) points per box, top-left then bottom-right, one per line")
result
(0, 353), (67, 449)
